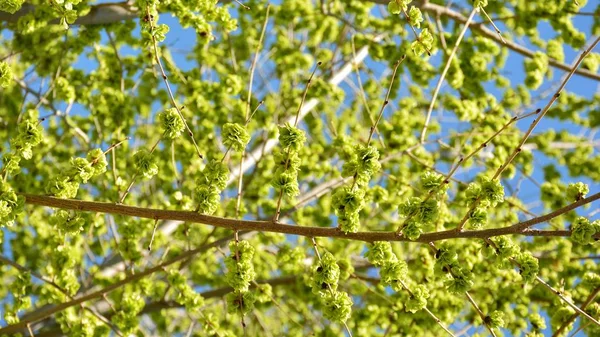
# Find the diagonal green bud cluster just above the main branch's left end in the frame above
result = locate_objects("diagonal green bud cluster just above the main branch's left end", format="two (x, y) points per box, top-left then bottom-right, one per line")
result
(46, 149), (108, 198)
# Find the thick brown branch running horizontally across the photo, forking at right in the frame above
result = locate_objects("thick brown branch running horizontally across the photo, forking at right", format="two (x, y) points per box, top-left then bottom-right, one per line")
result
(22, 192), (600, 243)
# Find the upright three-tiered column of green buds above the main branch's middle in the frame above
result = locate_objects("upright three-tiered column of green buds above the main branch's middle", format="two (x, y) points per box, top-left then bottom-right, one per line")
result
(271, 123), (306, 198)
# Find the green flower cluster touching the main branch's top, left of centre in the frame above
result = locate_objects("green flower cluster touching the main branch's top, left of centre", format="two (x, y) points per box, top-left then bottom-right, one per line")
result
(194, 160), (229, 214)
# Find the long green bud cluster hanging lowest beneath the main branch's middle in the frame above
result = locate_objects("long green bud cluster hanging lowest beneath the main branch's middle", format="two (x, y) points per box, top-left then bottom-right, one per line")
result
(310, 252), (353, 323)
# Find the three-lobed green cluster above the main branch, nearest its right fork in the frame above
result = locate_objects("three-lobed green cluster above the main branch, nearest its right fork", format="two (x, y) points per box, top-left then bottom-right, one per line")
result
(465, 177), (504, 229)
